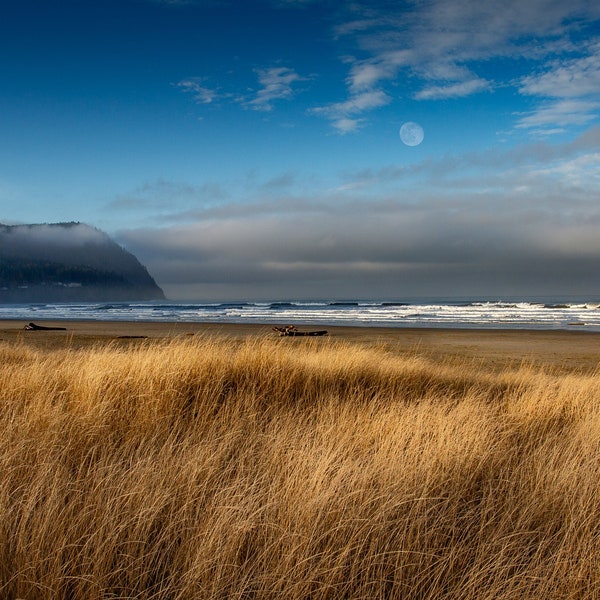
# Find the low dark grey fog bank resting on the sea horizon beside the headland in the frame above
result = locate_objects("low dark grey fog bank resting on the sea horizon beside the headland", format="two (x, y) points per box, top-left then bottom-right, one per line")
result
(120, 196), (600, 299)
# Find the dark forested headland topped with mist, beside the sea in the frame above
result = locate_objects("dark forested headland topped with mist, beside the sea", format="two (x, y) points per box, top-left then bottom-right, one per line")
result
(0, 223), (165, 303)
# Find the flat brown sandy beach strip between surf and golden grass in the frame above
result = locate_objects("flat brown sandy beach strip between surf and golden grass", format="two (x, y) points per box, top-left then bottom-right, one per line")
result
(0, 320), (600, 372)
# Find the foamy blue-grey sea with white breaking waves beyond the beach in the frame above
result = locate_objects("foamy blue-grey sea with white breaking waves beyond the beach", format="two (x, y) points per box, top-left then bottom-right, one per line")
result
(0, 297), (600, 331)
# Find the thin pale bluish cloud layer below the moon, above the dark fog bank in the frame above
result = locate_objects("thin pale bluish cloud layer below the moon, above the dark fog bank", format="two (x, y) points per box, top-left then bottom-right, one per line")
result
(345, 127), (600, 200)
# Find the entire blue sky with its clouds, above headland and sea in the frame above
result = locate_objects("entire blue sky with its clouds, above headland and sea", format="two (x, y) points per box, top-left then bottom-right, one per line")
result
(0, 0), (600, 301)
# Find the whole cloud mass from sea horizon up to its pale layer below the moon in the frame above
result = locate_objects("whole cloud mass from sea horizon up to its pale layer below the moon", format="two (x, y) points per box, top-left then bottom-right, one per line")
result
(119, 128), (600, 299)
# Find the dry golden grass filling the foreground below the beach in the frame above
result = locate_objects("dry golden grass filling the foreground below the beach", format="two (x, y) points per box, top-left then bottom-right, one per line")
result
(0, 337), (600, 600)
